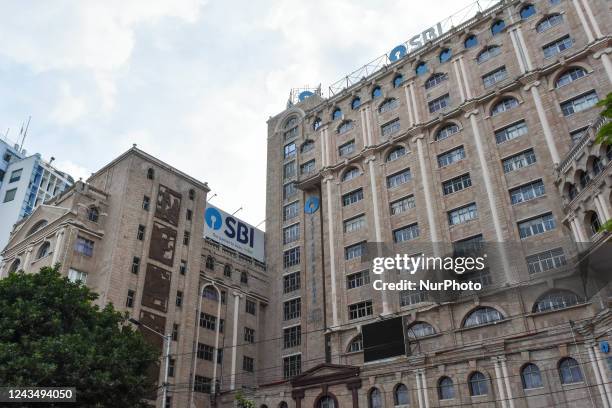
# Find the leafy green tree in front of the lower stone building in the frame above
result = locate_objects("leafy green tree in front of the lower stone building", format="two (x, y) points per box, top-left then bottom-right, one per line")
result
(0, 267), (159, 408)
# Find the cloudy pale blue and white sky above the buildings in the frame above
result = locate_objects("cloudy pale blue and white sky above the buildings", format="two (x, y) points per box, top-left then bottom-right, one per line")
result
(0, 0), (473, 228)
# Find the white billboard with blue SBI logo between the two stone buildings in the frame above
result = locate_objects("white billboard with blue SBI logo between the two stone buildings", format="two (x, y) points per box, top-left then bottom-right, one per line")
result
(204, 204), (266, 262)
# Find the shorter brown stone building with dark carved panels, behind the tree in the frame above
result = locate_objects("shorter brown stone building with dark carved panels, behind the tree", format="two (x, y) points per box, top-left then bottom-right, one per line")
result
(0, 147), (269, 407)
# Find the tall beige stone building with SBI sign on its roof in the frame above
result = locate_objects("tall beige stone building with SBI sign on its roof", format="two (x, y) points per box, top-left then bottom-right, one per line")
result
(253, 0), (612, 408)
